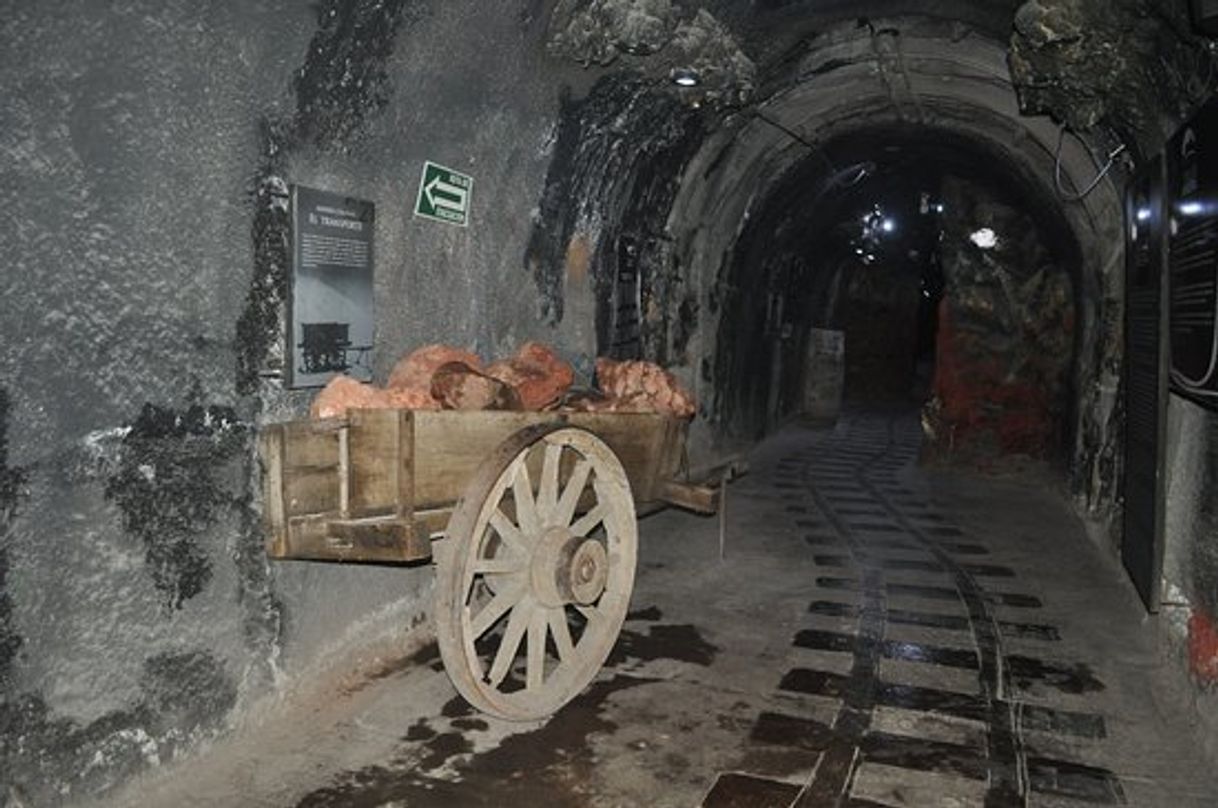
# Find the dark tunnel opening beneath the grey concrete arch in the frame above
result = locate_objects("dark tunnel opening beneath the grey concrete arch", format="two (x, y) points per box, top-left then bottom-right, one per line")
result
(716, 123), (1082, 455)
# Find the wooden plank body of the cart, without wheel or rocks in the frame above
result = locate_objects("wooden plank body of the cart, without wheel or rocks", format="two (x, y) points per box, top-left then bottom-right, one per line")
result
(261, 409), (687, 562)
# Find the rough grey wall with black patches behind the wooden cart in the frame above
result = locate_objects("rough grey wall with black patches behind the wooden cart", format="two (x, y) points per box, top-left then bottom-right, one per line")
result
(0, 0), (584, 804)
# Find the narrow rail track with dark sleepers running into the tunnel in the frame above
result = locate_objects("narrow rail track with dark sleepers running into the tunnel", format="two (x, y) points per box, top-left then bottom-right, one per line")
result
(704, 416), (1127, 808)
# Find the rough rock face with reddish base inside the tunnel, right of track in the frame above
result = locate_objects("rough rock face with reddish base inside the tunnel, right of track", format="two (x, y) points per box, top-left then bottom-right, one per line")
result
(924, 179), (1075, 464)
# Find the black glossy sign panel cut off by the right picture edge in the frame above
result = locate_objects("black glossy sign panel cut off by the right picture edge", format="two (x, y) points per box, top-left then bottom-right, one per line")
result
(1167, 102), (1218, 408)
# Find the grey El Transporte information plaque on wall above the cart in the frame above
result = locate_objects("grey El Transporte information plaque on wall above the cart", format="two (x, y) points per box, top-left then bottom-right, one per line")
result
(287, 185), (375, 388)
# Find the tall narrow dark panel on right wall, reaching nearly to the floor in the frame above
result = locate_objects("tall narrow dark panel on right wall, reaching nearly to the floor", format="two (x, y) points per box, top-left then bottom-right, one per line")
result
(1121, 158), (1168, 612)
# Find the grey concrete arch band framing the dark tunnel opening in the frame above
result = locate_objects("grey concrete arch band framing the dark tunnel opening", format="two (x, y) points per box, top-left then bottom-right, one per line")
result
(652, 6), (1122, 492)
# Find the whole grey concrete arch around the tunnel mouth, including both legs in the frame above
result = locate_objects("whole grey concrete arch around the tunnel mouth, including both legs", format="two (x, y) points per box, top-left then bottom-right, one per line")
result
(667, 18), (1123, 513)
